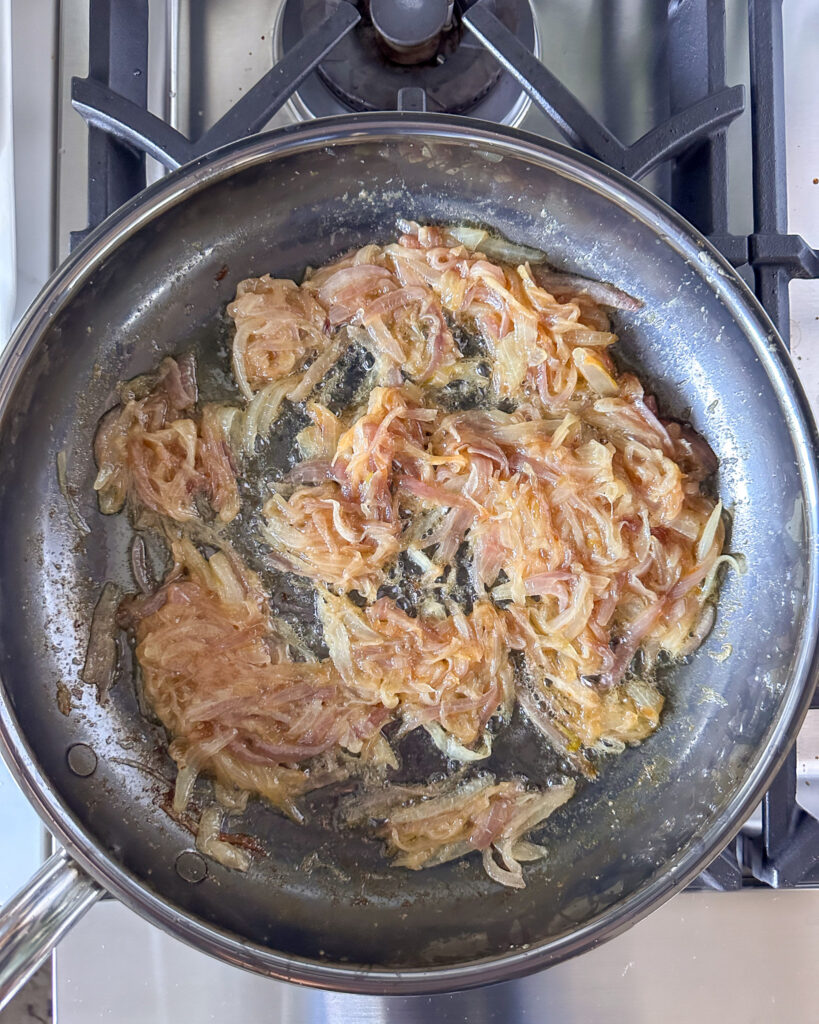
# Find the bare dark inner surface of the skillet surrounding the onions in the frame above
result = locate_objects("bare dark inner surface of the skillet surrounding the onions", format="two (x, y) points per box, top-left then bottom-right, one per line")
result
(0, 121), (815, 987)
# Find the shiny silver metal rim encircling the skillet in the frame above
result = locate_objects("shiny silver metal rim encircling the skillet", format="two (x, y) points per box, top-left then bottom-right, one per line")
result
(0, 114), (819, 993)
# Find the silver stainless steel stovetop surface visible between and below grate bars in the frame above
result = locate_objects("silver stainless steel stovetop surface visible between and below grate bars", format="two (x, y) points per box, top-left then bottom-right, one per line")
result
(0, 0), (819, 1024)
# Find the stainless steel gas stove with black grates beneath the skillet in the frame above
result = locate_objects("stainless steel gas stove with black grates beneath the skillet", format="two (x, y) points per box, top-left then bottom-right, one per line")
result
(0, 0), (819, 1024)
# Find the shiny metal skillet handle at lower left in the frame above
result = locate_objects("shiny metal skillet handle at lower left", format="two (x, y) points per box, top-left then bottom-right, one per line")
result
(0, 850), (103, 1010)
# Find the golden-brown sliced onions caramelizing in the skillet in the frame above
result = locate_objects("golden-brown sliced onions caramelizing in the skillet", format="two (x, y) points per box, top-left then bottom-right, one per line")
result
(91, 221), (730, 888)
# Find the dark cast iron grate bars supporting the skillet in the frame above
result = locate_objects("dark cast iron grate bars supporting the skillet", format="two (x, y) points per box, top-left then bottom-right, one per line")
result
(65, 0), (819, 890)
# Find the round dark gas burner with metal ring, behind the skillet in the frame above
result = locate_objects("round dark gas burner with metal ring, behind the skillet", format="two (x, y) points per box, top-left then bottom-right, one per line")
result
(274, 0), (537, 124)
